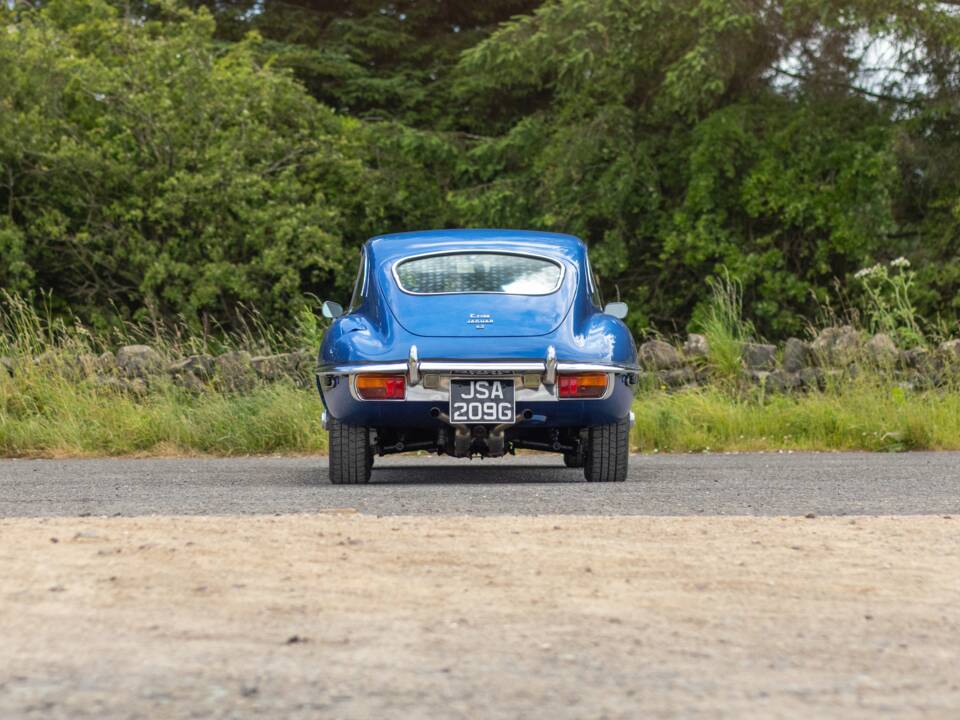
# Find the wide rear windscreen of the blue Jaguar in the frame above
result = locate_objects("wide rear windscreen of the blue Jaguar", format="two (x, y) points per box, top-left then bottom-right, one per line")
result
(394, 253), (563, 295)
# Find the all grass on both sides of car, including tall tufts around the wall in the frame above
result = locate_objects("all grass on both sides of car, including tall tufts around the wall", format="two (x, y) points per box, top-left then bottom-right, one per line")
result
(0, 292), (960, 457)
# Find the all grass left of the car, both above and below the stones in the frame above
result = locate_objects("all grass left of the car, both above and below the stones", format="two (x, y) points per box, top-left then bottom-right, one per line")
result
(0, 296), (326, 457)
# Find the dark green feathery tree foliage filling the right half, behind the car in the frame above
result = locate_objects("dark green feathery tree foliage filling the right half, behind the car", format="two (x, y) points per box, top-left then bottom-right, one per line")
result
(460, 0), (960, 336)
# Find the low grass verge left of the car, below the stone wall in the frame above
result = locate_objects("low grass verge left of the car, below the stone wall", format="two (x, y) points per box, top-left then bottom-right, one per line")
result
(0, 373), (326, 457)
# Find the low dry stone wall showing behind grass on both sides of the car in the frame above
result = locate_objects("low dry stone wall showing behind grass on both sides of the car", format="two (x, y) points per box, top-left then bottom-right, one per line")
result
(0, 326), (960, 394)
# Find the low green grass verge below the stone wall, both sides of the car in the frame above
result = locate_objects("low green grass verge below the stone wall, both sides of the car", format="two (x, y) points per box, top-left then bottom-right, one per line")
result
(0, 368), (960, 457)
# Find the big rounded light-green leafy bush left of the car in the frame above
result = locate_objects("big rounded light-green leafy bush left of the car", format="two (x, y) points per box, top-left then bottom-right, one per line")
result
(0, 0), (362, 330)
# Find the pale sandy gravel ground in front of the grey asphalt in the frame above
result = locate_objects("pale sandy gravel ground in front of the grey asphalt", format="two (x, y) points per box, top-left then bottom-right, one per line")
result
(0, 514), (960, 720)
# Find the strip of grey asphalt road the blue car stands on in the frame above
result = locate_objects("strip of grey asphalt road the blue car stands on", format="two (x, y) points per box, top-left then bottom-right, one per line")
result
(0, 453), (960, 517)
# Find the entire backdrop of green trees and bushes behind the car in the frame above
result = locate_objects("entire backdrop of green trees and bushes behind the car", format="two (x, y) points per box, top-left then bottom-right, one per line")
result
(0, 0), (960, 338)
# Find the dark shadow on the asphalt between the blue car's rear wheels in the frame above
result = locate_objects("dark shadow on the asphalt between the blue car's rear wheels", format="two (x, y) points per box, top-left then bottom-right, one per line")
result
(362, 465), (583, 485)
